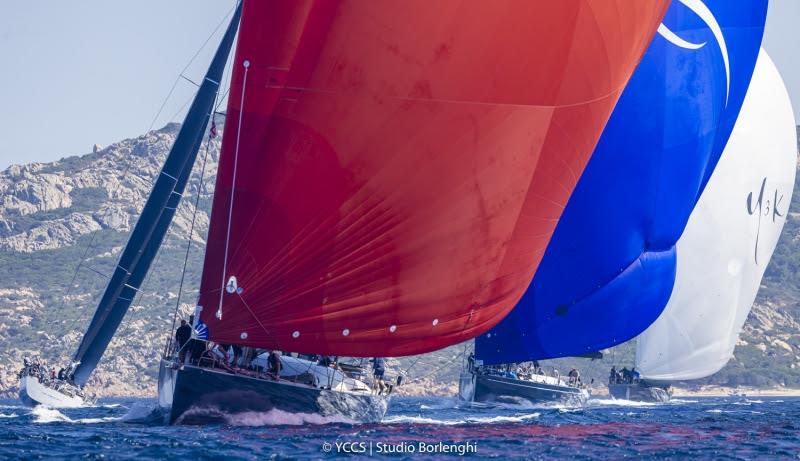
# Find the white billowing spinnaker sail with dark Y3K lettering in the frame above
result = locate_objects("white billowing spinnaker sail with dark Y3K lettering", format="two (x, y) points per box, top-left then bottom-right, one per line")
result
(636, 49), (797, 381)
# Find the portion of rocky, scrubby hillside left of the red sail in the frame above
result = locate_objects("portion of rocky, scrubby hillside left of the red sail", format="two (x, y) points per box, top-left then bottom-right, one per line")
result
(0, 124), (219, 394)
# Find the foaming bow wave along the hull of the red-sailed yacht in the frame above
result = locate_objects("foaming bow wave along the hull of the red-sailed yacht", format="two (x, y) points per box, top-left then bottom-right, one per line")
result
(176, 408), (357, 427)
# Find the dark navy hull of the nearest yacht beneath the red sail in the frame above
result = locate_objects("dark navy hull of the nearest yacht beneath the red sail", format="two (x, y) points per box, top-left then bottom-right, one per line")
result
(158, 360), (389, 424)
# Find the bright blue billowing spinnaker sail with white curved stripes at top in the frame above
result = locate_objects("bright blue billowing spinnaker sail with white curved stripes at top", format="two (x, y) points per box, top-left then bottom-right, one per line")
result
(476, 0), (767, 364)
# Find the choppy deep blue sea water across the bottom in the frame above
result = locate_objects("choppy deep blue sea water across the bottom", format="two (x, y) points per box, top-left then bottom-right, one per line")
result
(0, 397), (800, 461)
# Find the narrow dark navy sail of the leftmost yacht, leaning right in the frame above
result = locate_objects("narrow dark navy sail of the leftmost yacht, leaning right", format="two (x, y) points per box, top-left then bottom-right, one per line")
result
(73, 3), (241, 385)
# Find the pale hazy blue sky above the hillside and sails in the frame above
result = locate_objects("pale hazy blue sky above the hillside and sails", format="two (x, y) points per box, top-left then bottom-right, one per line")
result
(0, 0), (800, 169)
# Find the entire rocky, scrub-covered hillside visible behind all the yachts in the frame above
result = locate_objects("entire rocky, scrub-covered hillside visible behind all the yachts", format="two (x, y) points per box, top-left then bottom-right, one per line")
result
(0, 125), (800, 395)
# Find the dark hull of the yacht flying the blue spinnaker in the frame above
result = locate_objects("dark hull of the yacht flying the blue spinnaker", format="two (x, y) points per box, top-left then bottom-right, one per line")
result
(460, 374), (589, 406)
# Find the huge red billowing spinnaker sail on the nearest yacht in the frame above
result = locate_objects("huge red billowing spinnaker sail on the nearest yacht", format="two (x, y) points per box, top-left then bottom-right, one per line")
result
(199, 0), (668, 356)
